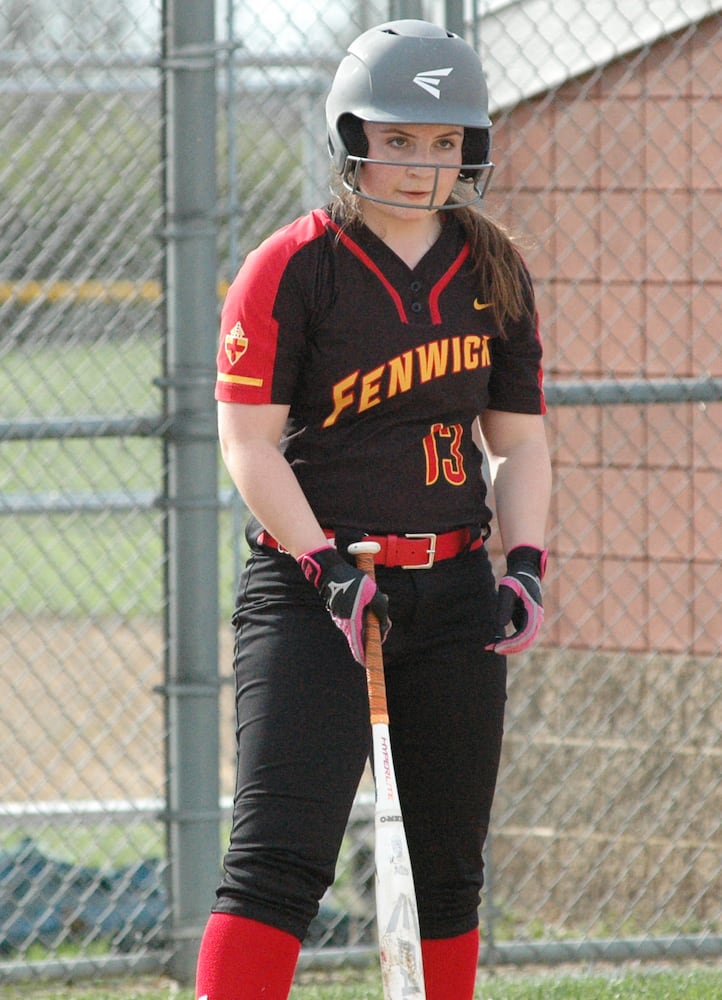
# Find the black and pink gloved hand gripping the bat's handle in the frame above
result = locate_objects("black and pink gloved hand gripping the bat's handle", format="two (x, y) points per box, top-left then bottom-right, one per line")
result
(298, 545), (391, 666)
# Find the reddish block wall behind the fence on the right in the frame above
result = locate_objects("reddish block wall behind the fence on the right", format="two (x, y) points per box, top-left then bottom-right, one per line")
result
(489, 15), (722, 655)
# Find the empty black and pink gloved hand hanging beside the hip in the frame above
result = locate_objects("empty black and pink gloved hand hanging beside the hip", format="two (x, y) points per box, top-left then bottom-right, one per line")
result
(485, 545), (547, 655)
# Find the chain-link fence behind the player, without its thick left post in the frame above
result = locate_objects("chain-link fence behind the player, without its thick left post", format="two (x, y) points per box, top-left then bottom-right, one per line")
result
(0, 0), (722, 981)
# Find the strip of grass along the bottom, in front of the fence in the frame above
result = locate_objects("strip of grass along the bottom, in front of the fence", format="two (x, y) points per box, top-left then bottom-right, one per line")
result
(0, 965), (722, 1000)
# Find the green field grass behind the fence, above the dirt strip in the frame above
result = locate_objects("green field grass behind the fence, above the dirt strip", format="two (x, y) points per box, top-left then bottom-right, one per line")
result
(0, 339), (242, 620)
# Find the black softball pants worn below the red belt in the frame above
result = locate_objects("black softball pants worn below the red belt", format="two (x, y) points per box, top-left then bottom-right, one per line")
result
(213, 547), (506, 940)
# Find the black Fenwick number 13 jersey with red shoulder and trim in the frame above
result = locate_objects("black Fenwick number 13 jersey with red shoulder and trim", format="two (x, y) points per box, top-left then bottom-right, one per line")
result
(216, 209), (545, 533)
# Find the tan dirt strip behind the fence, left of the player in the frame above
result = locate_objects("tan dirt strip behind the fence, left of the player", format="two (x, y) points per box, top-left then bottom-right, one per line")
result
(0, 615), (234, 803)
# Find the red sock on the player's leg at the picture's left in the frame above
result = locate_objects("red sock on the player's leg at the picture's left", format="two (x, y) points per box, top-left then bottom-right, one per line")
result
(196, 913), (301, 1000)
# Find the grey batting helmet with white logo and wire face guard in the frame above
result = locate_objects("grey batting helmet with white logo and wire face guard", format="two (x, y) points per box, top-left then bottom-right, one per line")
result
(326, 20), (493, 210)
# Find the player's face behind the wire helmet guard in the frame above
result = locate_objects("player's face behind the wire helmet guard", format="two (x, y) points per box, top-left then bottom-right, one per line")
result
(352, 122), (464, 215)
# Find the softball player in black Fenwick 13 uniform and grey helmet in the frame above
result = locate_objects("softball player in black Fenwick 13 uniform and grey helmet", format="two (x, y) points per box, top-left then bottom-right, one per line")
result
(197, 21), (550, 1000)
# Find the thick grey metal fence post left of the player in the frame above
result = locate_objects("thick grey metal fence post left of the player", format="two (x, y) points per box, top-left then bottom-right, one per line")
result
(163, 0), (220, 982)
